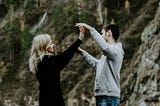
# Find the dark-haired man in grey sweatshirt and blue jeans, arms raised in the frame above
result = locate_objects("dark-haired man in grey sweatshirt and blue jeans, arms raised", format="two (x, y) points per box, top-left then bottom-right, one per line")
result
(76, 23), (124, 106)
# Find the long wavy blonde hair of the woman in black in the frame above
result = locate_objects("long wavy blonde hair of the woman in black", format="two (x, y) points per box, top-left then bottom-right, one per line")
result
(29, 34), (51, 73)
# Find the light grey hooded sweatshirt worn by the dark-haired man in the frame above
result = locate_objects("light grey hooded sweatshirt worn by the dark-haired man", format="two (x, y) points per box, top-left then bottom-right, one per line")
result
(82, 28), (124, 97)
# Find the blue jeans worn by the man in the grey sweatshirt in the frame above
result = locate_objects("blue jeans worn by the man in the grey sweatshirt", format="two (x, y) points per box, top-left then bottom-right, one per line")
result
(96, 96), (120, 106)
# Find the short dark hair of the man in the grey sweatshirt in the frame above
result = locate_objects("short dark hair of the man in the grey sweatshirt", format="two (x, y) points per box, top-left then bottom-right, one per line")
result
(104, 24), (119, 41)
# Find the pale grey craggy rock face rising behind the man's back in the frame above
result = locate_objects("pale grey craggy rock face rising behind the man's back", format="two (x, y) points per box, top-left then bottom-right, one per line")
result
(122, 1), (160, 106)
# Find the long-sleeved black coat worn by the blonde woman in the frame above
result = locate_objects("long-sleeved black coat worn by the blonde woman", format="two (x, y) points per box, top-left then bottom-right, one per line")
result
(36, 39), (82, 106)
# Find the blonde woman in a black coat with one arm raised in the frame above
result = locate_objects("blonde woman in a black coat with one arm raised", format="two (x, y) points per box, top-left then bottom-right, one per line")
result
(29, 34), (83, 106)
